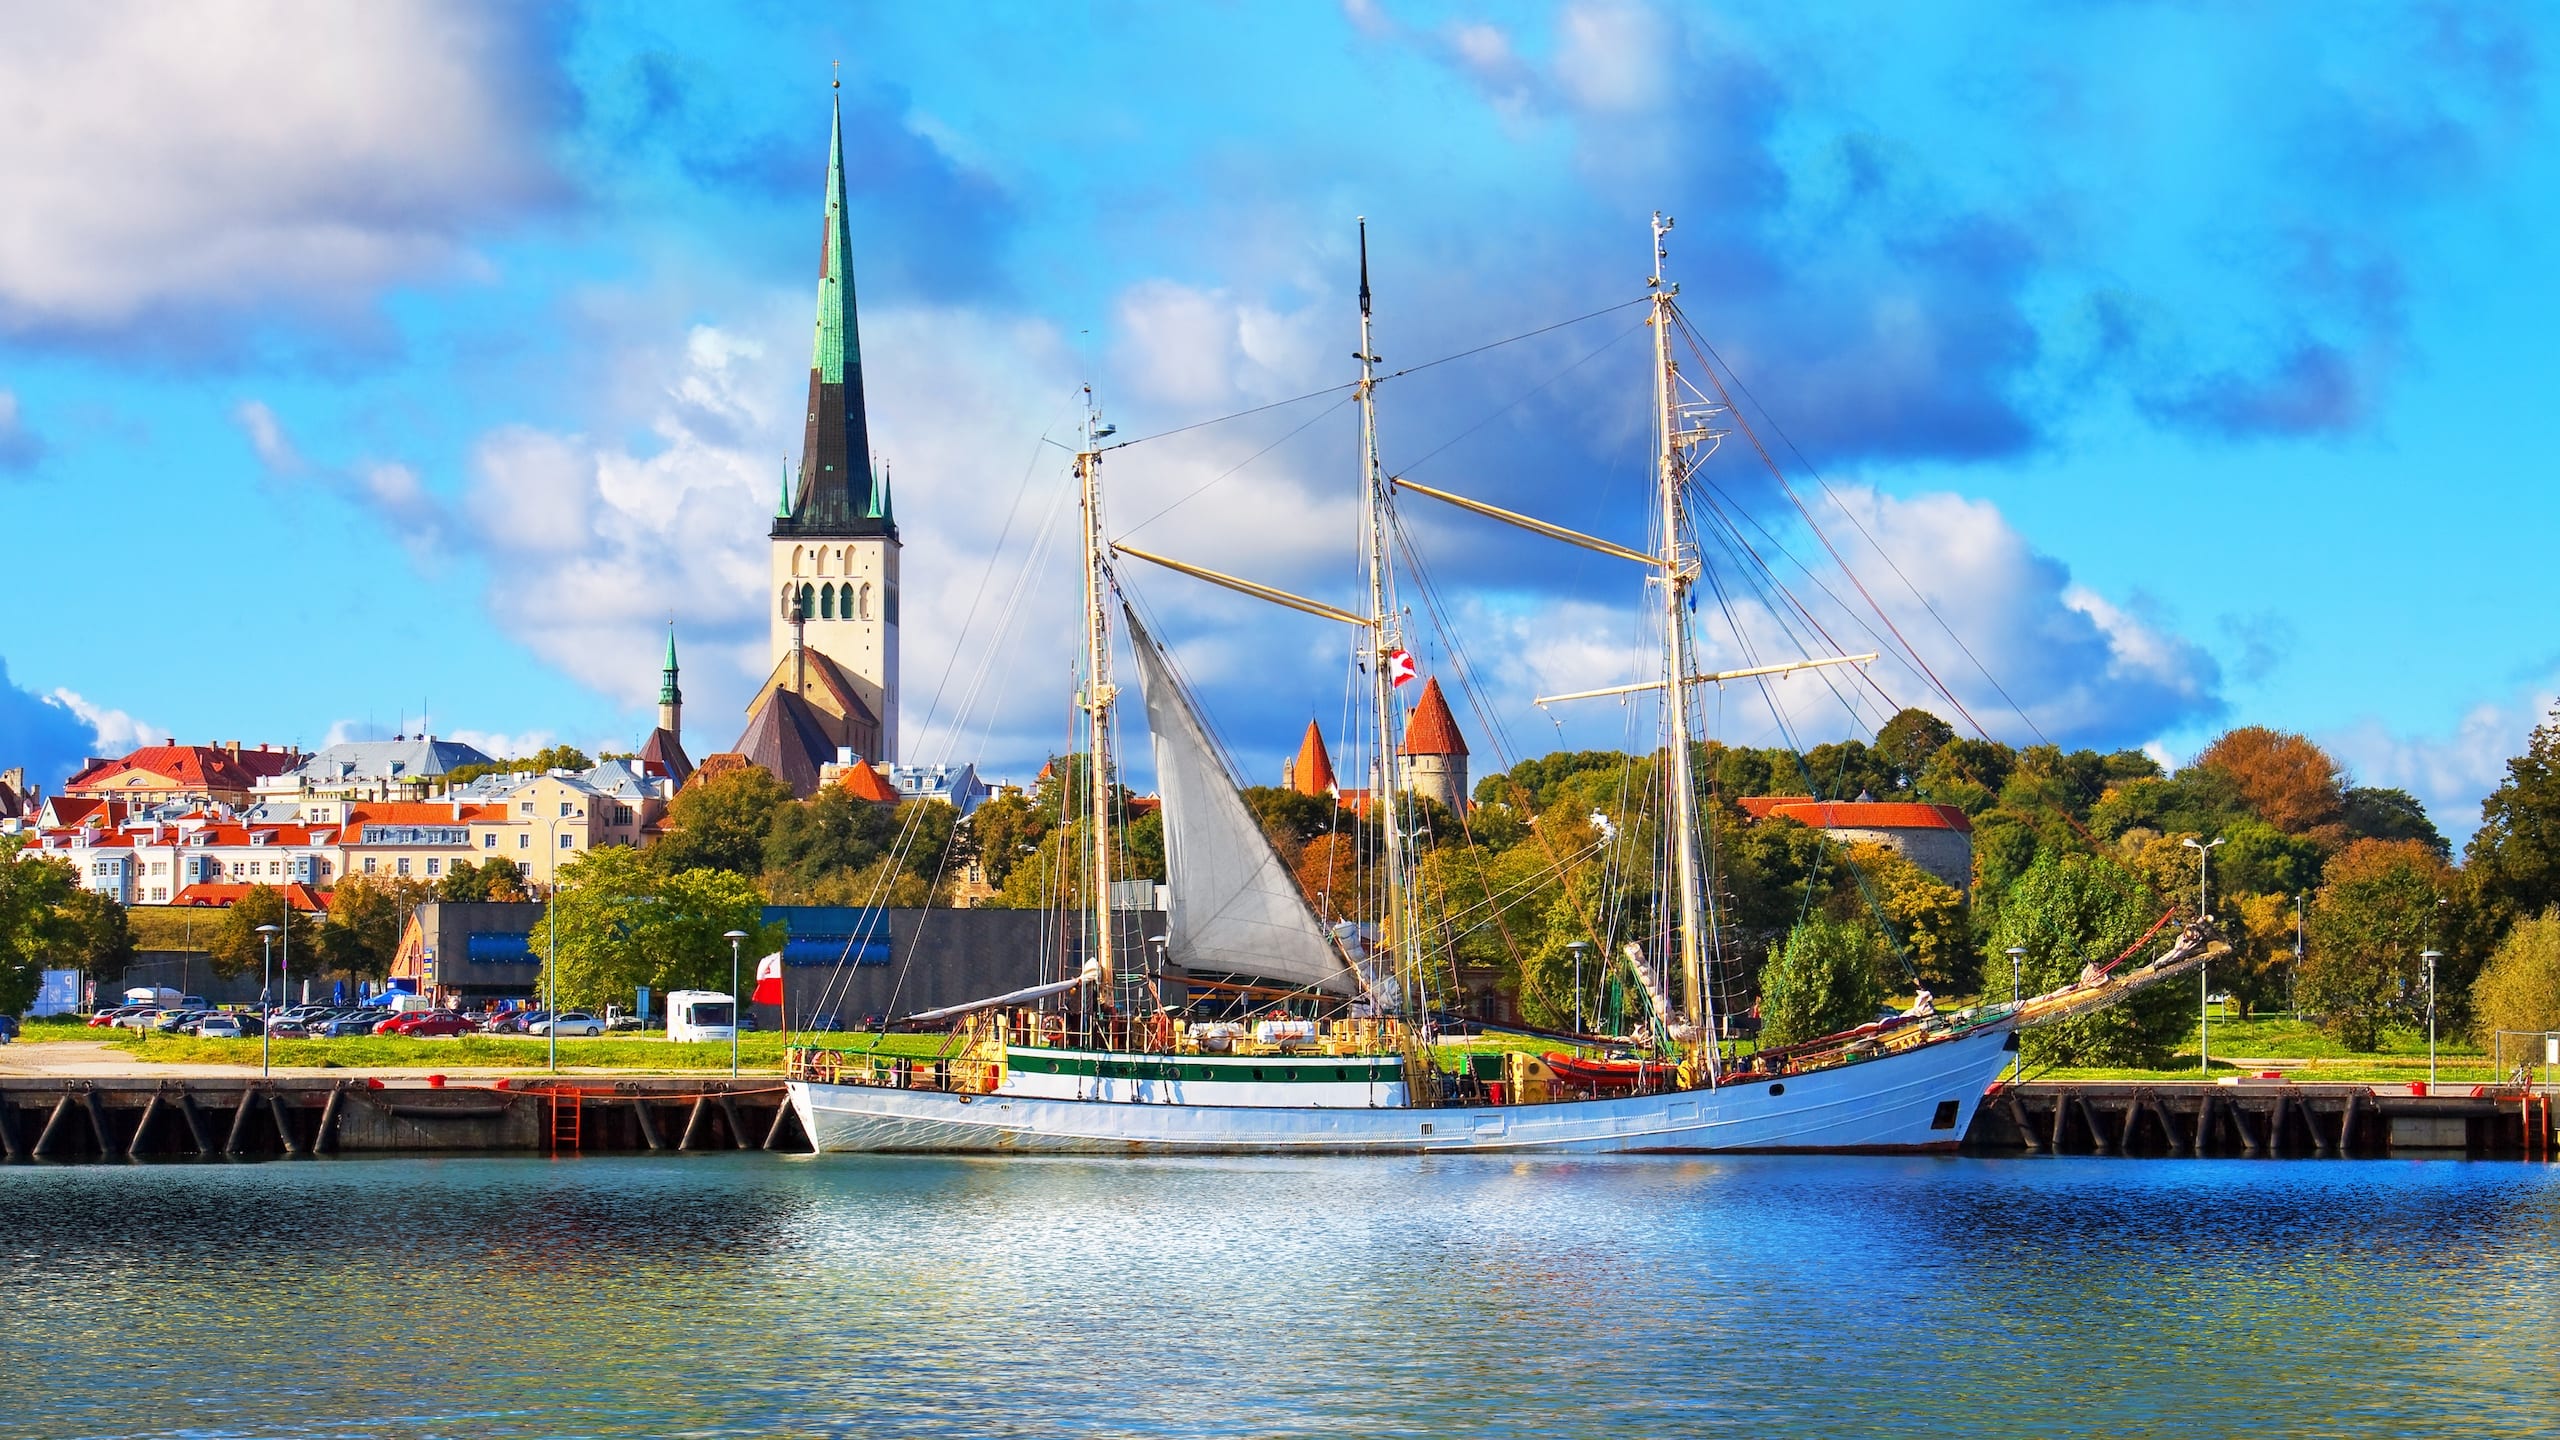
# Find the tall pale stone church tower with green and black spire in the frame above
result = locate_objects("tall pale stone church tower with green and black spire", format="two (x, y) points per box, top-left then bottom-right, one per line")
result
(765, 82), (899, 764)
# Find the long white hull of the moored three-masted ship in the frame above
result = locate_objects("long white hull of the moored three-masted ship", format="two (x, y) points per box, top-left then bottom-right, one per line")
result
(791, 1025), (2012, 1156)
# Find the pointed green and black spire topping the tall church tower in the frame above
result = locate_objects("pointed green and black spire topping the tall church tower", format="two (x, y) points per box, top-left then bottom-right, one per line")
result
(773, 79), (896, 536)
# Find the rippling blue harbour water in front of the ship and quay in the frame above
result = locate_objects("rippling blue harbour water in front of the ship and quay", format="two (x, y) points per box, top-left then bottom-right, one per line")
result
(0, 1156), (2560, 1437)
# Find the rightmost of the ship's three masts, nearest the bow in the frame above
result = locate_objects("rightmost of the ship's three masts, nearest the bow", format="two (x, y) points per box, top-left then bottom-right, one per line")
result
(1649, 210), (1720, 1076)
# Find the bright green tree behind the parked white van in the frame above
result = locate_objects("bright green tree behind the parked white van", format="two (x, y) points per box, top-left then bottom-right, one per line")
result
(535, 846), (781, 1007)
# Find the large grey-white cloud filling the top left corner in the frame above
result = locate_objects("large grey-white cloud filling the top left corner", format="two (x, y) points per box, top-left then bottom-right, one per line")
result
(0, 0), (568, 336)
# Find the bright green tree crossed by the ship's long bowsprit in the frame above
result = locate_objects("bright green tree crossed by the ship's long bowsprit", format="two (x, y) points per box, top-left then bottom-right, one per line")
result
(1987, 851), (2191, 1068)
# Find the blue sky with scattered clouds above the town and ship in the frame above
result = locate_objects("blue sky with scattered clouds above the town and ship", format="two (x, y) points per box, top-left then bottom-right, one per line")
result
(0, 0), (2560, 833)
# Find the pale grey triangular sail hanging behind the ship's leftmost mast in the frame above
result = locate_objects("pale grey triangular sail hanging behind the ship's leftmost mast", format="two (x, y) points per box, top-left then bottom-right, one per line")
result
(1124, 607), (1359, 994)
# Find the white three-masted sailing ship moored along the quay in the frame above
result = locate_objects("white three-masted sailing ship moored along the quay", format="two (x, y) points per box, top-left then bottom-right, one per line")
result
(788, 215), (2225, 1156)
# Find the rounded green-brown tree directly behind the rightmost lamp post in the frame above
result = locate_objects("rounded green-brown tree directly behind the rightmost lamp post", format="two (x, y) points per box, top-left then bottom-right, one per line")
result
(2299, 840), (2468, 1051)
